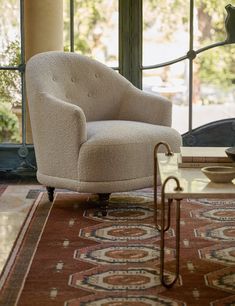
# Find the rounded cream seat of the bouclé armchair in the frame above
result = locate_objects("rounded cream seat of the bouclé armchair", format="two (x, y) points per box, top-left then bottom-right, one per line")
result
(78, 120), (181, 182)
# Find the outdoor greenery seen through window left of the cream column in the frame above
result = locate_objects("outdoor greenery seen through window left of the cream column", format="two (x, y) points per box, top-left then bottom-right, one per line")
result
(0, 0), (22, 143)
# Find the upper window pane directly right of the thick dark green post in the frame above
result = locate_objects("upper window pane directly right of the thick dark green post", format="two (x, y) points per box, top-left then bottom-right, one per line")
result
(143, 0), (189, 66)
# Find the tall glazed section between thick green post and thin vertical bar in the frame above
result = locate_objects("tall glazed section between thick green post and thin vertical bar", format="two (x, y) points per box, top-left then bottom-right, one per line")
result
(143, 0), (189, 133)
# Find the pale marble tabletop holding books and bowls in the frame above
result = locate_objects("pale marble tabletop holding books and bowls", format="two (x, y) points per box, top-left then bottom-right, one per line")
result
(157, 153), (235, 198)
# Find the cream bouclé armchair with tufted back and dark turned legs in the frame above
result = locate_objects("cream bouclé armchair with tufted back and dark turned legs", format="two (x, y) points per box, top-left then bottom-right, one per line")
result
(26, 51), (181, 213)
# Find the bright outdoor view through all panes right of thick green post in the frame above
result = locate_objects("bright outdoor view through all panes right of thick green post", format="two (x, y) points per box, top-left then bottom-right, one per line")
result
(143, 0), (235, 133)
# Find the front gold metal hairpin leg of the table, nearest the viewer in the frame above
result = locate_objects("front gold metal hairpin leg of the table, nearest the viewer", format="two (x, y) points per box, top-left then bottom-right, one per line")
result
(160, 176), (183, 288)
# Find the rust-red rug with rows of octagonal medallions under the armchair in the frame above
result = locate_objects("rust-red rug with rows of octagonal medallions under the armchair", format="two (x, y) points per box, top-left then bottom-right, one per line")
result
(0, 189), (235, 306)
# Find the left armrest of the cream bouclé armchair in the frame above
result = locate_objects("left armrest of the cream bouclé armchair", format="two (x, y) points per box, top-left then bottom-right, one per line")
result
(30, 93), (87, 179)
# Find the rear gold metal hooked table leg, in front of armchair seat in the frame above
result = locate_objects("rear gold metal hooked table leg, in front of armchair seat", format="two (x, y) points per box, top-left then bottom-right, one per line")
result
(154, 141), (174, 231)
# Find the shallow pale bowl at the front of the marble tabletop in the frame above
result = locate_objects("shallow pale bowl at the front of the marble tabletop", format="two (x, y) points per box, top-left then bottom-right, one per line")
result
(201, 166), (235, 183)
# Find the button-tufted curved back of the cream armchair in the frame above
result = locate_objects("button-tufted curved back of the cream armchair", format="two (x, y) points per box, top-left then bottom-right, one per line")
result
(27, 51), (131, 121)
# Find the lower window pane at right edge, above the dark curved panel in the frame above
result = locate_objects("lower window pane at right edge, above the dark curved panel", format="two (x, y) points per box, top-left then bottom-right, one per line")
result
(193, 45), (235, 128)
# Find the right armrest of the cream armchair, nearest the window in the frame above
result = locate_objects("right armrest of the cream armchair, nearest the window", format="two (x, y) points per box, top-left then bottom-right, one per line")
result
(119, 85), (172, 126)
